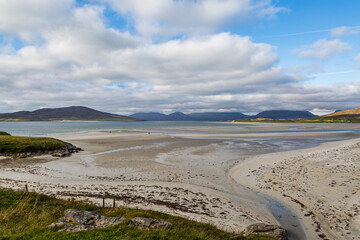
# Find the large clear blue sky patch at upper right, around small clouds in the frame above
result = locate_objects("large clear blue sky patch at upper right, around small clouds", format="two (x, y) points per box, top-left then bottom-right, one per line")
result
(230, 0), (360, 85)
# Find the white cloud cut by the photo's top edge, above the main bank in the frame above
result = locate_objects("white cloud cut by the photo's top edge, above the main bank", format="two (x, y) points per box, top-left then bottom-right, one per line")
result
(99, 0), (286, 38)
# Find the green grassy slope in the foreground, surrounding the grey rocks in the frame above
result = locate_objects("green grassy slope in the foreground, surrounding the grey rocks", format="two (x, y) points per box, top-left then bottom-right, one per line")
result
(0, 190), (274, 240)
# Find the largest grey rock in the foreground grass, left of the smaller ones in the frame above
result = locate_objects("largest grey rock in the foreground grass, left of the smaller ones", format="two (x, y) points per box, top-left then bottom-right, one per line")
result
(49, 209), (125, 232)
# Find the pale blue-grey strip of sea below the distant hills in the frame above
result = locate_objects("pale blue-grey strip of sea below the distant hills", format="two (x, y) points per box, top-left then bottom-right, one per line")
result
(0, 121), (360, 136)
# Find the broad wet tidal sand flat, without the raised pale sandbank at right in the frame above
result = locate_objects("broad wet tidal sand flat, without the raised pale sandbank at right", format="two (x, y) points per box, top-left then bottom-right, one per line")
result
(0, 124), (359, 239)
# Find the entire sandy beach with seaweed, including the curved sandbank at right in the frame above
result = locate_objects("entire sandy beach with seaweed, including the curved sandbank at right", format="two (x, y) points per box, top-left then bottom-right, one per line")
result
(0, 124), (360, 239)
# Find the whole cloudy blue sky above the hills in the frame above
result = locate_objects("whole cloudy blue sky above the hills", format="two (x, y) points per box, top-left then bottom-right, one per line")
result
(0, 0), (360, 115)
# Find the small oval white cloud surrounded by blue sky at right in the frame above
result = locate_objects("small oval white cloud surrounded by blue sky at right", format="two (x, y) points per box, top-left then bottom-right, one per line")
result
(292, 39), (350, 60)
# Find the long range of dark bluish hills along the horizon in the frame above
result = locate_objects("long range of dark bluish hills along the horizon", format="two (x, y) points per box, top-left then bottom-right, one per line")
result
(0, 106), (320, 121)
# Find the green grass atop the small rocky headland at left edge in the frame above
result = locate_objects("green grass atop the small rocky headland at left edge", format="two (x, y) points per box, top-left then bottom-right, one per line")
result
(0, 132), (65, 155)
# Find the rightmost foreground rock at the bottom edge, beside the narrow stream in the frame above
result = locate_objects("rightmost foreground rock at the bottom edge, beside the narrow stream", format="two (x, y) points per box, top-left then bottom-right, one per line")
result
(241, 223), (287, 240)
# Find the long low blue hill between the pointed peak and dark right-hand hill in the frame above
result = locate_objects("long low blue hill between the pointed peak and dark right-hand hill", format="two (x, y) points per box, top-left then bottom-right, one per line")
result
(189, 112), (250, 121)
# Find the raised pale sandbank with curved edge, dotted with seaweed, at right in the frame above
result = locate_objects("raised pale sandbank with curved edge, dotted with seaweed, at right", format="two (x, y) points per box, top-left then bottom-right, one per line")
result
(229, 139), (360, 239)
